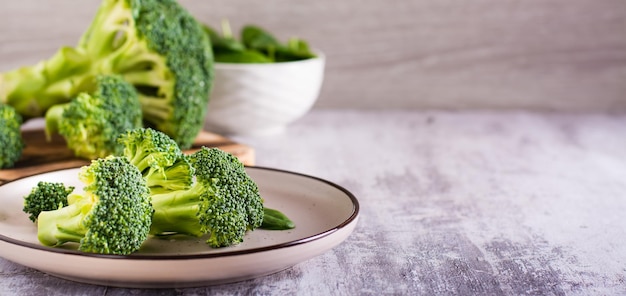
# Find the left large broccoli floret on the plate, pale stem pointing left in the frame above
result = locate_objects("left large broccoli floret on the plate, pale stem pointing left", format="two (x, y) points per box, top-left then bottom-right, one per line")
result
(37, 156), (153, 255)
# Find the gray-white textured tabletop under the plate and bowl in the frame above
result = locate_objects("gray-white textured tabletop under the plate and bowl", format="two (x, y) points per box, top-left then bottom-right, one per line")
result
(0, 110), (626, 295)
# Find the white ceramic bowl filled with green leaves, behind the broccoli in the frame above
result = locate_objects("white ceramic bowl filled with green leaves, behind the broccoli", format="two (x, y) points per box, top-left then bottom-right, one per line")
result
(204, 52), (325, 135)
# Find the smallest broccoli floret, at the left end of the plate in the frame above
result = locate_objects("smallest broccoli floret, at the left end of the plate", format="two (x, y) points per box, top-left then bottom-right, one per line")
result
(22, 181), (74, 222)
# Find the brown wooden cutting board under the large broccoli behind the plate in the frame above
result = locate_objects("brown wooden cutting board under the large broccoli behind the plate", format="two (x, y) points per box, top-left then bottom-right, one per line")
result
(0, 130), (255, 184)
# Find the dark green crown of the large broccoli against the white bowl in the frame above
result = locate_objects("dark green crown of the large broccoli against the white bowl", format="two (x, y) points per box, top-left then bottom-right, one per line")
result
(132, 0), (213, 148)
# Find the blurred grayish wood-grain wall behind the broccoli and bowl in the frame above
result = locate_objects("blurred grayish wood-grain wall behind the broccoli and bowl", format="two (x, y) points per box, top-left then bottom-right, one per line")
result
(0, 0), (626, 112)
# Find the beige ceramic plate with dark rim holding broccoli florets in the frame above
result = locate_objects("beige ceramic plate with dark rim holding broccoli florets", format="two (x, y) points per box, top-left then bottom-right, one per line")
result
(0, 167), (359, 288)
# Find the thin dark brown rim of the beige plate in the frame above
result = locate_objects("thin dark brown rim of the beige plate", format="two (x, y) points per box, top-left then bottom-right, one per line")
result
(0, 165), (360, 261)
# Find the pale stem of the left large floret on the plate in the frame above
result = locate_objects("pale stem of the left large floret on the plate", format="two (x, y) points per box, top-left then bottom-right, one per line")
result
(37, 194), (91, 247)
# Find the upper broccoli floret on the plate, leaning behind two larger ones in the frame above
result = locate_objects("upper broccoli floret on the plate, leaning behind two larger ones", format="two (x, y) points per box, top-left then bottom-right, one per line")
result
(118, 128), (193, 194)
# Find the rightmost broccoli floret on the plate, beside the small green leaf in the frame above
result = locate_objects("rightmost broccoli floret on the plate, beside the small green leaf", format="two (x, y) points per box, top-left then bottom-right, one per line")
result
(151, 147), (263, 248)
